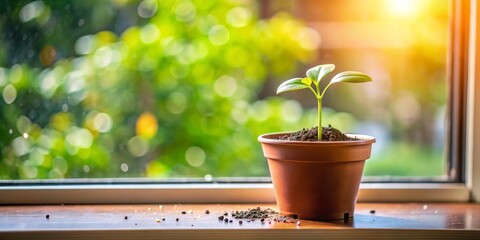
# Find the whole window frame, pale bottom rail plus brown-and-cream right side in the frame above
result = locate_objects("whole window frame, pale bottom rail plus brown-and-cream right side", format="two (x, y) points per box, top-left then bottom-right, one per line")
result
(0, 0), (480, 204)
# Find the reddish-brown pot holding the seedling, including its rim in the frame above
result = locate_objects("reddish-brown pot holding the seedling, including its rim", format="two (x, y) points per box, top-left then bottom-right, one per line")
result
(258, 133), (375, 220)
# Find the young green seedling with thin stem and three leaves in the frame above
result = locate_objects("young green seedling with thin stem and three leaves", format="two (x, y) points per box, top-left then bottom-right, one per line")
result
(277, 64), (372, 141)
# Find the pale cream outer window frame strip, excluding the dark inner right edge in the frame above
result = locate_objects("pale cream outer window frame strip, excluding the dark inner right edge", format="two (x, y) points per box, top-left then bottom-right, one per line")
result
(0, 0), (480, 204)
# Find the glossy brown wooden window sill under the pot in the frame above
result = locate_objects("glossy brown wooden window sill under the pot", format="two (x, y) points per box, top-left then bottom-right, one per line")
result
(0, 203), (480, 239)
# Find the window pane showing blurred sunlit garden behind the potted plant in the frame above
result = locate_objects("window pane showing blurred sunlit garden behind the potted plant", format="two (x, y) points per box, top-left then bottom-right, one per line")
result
(0, 0), (449, 180)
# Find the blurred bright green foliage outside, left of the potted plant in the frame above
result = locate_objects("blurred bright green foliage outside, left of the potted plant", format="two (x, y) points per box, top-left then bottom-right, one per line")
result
(0, 1), (322, 179)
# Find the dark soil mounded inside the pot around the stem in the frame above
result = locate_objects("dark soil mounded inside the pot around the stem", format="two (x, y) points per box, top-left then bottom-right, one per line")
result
(278, 125), (358, 142)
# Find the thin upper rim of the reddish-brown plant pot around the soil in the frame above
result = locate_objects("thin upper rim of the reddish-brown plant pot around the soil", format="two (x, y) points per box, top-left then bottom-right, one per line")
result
(258, 132), (375, 146)
